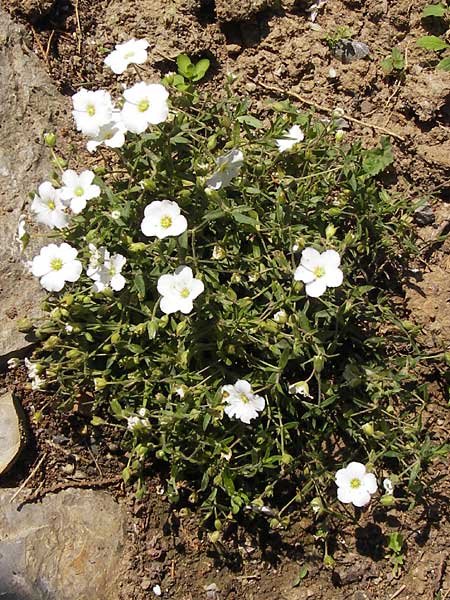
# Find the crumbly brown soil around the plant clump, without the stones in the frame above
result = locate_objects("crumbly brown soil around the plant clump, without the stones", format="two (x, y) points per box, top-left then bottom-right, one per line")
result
(1, 0), (450, 600)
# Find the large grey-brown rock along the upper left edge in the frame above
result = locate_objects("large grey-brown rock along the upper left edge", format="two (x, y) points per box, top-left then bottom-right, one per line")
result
(0, 8), (64, 367)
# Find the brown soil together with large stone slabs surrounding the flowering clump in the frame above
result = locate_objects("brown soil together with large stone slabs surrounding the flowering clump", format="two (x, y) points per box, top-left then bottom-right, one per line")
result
(0, 0), (450, 600)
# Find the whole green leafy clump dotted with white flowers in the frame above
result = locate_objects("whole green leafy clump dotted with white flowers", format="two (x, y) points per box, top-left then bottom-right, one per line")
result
(21, 45), (442, 529)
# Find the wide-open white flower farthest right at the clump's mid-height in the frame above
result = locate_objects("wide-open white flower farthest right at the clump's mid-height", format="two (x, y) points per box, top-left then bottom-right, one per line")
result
(294, 248), (343, 298)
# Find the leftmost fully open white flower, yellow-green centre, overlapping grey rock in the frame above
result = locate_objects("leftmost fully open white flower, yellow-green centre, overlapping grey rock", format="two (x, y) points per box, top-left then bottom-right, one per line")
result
(31, 242), (82, 292)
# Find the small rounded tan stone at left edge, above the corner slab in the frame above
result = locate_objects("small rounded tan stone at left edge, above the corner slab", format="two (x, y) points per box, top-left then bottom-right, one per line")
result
(0, 392), (24, 475)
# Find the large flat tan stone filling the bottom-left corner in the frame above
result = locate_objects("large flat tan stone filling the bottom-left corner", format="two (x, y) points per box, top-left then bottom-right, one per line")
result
(0, 489), (126, 600)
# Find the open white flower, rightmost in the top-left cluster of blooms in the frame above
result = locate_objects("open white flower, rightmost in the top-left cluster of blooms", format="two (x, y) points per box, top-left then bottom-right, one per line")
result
(122, 81), (169, 133)
